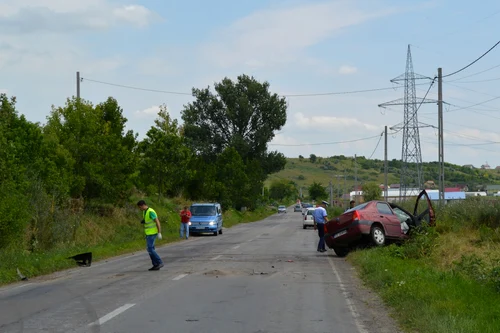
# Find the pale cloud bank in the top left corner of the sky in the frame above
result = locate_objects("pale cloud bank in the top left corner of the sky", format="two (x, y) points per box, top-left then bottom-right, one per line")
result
(0, 0), (158, 34)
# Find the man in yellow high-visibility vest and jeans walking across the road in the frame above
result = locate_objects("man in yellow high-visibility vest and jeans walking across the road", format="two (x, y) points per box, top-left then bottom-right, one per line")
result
(137, 200), (163, 271)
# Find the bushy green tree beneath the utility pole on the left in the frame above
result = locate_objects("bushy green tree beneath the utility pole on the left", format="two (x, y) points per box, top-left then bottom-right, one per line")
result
(45, 97), (137, 202)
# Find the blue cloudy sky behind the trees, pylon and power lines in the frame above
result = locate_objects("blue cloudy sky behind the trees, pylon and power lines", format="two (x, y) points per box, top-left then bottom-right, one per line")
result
(0, 0), (500, 167)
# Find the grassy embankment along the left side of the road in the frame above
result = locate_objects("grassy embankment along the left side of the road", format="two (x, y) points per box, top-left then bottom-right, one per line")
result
(0, 198), (275, 285)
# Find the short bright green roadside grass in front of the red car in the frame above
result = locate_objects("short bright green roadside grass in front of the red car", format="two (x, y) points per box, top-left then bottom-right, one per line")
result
(349, 248), (500, 333)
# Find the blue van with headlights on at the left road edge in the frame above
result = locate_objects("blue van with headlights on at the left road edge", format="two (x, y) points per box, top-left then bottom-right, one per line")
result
(189, 203), (223, 236)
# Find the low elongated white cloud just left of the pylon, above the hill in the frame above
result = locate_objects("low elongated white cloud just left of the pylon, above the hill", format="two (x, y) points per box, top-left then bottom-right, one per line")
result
(293, 112), (380, 133)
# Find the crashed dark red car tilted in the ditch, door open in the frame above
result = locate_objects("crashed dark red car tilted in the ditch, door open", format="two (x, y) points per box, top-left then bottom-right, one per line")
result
(325, 190), (436, 257)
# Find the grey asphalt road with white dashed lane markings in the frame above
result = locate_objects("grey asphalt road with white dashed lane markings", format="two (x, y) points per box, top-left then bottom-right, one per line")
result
(0, 209), (397, 333)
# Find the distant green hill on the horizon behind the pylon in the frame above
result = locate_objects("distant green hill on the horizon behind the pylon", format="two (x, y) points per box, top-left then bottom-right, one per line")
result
(266, 155), (500, 194)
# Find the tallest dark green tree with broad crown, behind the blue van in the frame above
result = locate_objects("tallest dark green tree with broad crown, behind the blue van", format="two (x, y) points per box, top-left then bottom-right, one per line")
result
(182, 75), (287, 208)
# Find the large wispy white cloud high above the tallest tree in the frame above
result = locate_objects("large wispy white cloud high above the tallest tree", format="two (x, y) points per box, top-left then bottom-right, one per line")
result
(204, 1), (395, 67)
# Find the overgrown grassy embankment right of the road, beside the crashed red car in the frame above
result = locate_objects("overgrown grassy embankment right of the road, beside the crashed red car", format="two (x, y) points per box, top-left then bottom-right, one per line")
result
(348, 199), (500, 333)
